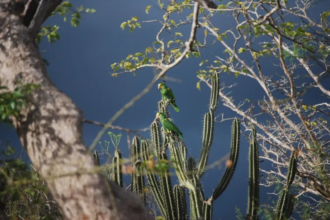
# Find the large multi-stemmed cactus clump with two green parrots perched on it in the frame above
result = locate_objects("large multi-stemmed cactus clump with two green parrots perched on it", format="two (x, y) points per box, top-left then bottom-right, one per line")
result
(92, 74), (245, 220)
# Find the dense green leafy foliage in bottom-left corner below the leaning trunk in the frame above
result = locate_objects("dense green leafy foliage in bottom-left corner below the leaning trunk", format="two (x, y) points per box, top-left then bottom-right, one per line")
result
(0, 146), (62, 220)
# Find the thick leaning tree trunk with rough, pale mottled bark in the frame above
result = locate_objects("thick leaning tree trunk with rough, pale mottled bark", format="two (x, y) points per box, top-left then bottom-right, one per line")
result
(0, 0), (151, 220)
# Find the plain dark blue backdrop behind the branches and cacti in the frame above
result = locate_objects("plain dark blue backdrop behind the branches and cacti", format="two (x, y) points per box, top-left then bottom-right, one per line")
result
(0, 0), (328, 220)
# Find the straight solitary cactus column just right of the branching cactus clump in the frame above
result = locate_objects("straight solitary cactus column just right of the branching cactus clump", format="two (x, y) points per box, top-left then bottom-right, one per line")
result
(247, 127), (259, 220)
